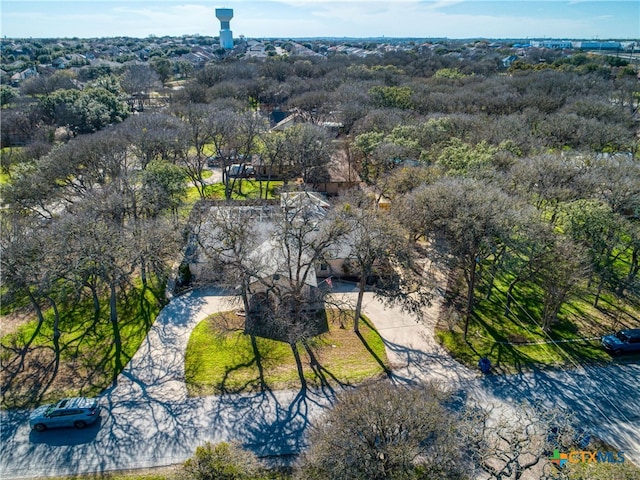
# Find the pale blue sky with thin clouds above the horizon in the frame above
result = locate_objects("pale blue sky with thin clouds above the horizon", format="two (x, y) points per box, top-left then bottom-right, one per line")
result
(0, 0), (640, 39)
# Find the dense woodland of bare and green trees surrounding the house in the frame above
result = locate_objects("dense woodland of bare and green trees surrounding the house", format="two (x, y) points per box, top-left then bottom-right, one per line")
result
(1, 38), (640, 401)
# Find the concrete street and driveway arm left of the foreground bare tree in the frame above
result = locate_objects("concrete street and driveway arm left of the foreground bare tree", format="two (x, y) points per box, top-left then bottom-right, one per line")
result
(0, 291), (331, 479)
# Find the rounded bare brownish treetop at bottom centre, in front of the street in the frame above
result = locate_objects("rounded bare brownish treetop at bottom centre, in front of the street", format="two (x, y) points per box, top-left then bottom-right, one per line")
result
(298, 382), (471, 480)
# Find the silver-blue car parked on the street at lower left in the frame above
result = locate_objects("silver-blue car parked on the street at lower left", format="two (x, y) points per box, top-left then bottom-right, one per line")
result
(29, 397), (100, 432)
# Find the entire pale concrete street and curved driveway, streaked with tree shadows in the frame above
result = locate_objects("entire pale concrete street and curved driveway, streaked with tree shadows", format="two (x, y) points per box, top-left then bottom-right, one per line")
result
(0, 285), (640, 479)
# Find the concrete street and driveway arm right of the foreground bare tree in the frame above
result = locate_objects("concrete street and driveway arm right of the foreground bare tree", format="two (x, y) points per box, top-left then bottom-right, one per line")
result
(350, 286), (640, 466)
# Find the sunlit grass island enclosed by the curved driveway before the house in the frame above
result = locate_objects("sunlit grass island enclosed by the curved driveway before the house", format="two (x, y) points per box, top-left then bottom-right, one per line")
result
(185, 310), (388, 395)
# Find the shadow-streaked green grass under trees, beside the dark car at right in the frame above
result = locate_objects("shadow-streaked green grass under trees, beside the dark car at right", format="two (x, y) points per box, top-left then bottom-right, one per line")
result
(436, 272), (640, 373)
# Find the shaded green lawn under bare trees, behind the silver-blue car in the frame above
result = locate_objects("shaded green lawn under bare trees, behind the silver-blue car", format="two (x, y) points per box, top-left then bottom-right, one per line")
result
(0, 289), (161, 407)
